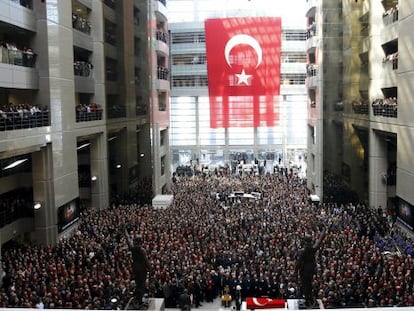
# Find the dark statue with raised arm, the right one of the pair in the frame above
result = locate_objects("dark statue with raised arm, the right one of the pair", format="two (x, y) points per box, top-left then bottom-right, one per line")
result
(296, 225), (327, 307)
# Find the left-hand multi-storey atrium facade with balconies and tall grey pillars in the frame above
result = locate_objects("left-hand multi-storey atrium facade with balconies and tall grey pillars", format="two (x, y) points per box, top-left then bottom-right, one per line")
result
(0, 0), (170, 247)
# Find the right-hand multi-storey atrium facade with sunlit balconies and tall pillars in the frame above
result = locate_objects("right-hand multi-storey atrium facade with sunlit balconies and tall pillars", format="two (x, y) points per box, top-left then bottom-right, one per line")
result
(306, 0), (414, 224)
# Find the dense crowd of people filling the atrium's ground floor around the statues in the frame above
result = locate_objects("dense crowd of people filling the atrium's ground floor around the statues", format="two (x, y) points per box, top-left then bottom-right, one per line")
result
(0, 173), (414, 309)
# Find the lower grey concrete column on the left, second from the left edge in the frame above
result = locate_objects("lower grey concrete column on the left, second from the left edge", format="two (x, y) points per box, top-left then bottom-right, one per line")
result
(90, 133), (109, 210)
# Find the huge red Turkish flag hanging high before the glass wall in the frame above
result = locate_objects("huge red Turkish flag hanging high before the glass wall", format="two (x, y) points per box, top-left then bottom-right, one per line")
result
(205, 17), (281, 128)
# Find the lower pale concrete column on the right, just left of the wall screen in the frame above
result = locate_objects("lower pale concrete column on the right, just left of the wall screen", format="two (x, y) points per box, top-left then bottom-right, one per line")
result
(369, 132), (388, 208)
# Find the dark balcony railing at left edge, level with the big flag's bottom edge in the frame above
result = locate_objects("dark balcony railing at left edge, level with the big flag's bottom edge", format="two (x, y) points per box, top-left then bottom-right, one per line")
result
(0, 111), (50, 131)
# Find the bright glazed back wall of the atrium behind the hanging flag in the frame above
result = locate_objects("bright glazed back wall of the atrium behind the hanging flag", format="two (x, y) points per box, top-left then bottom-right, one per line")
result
(169, 0), (307, 170)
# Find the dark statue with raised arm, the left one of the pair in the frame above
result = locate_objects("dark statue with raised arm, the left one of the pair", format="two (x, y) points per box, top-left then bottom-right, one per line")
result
(124, 228), (150, 309)
